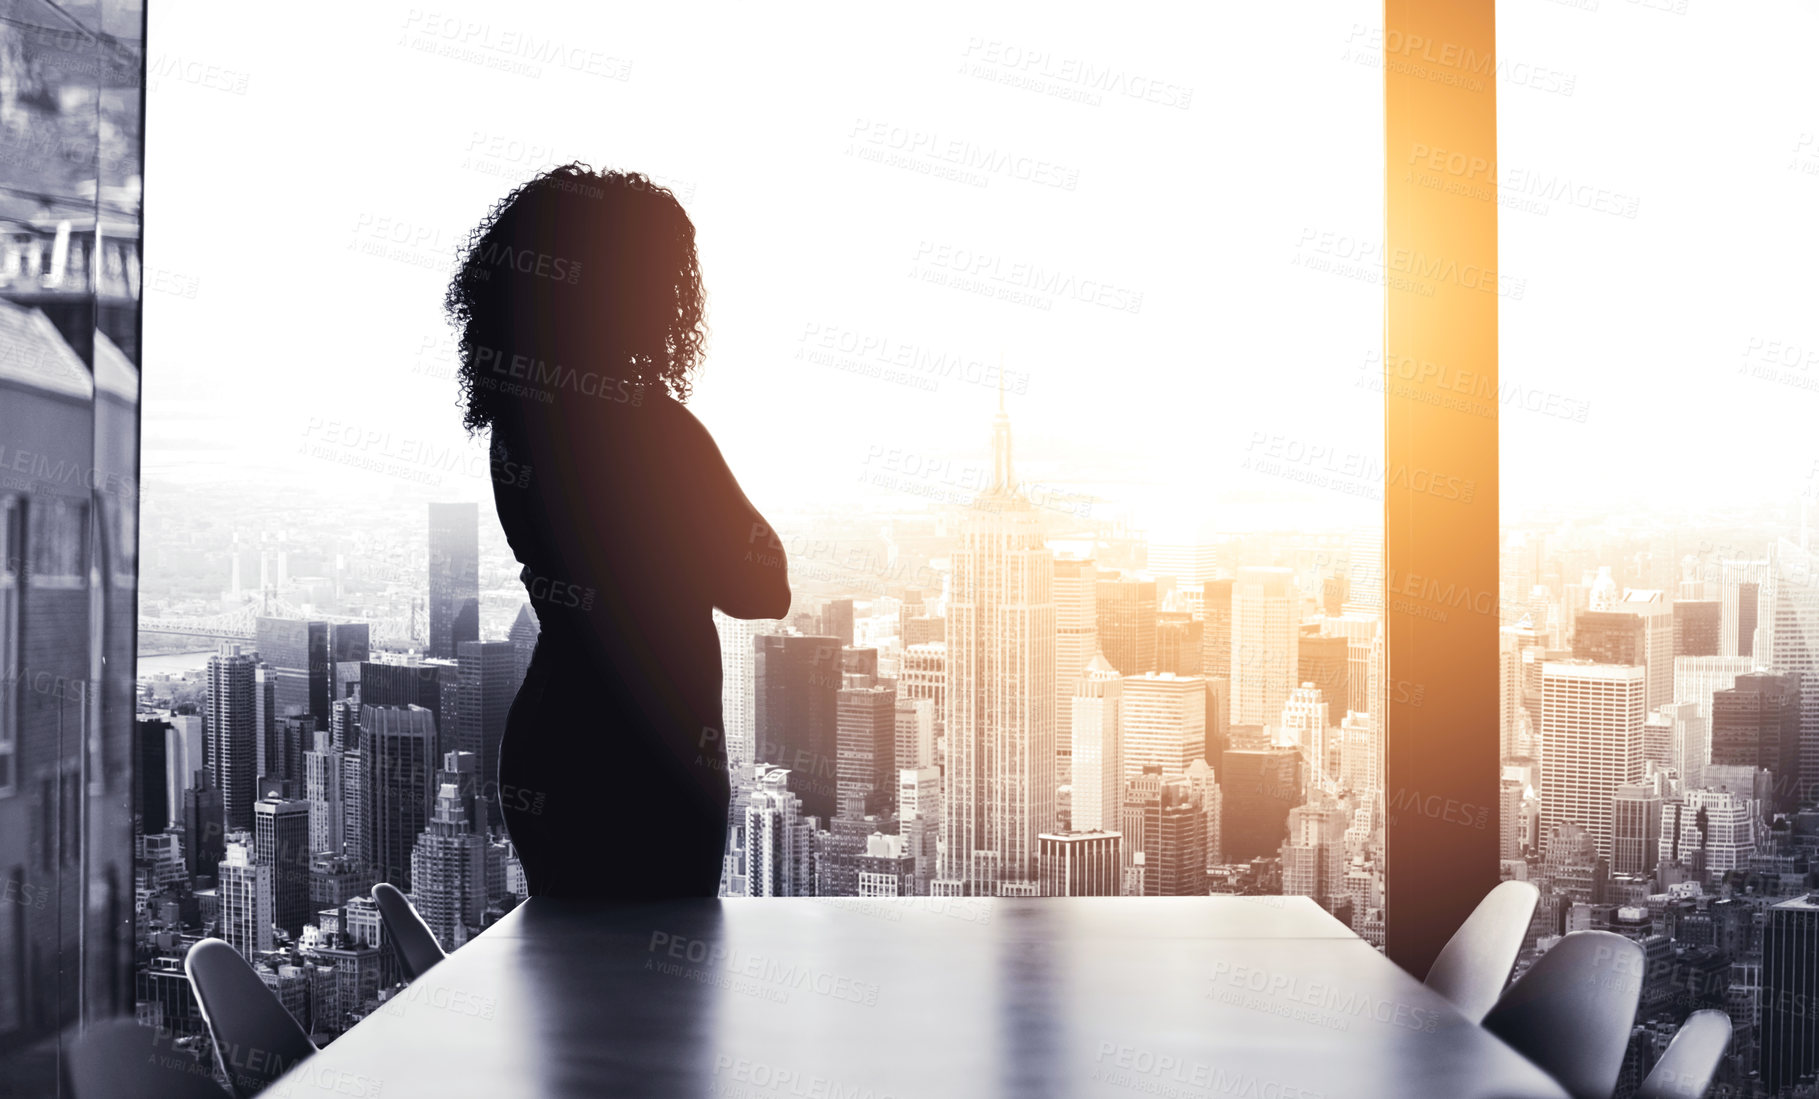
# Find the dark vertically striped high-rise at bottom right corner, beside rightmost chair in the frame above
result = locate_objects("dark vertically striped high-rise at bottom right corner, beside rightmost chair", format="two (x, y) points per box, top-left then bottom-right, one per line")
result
(1761, 893), (1819, 1094)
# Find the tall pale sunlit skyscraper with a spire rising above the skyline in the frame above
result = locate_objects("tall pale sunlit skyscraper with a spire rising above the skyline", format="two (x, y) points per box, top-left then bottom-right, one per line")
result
(940, 393), (1055, 897)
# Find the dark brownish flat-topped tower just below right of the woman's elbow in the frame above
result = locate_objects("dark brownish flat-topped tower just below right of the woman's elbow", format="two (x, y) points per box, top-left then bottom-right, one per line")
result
(753, 633), (842, 822)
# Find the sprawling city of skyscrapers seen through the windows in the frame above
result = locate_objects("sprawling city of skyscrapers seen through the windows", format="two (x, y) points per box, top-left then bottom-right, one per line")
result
(133, 397), (1819, 1095)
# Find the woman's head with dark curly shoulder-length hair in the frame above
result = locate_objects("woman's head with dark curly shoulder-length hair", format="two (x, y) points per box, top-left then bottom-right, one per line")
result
(444, 164), (708, 431)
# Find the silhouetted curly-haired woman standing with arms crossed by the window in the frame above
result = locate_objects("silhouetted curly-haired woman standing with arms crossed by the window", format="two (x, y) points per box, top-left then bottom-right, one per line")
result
(446, 164), (789, 897)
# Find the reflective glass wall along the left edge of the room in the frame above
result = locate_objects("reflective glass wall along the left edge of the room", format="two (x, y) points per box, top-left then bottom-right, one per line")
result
(0, 0), (144, 1094)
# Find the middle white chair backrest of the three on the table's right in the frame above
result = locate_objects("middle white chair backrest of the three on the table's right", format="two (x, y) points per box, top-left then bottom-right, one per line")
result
(1484, 932), (1644, 1099)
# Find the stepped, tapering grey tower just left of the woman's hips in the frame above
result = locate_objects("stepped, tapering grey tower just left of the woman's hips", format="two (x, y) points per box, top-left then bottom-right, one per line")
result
(411, 749), (487, 950)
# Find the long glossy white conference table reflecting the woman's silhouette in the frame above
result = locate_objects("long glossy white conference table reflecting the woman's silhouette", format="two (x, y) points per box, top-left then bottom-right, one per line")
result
(271, 897), (1566, 1099)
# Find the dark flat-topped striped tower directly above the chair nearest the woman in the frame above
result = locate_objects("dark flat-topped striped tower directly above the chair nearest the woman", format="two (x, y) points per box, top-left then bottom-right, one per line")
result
(360, 706), (437, 892)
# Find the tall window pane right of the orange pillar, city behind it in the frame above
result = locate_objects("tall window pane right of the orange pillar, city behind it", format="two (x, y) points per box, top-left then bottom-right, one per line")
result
(1495, 2), (1819, 1094)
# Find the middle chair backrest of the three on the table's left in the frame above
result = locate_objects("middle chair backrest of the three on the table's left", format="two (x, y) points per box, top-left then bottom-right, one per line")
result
(184, 939), (317, 1099)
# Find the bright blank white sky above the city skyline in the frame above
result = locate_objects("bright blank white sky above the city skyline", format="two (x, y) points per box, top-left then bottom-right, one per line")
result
(146, 0), (1819, 531)
